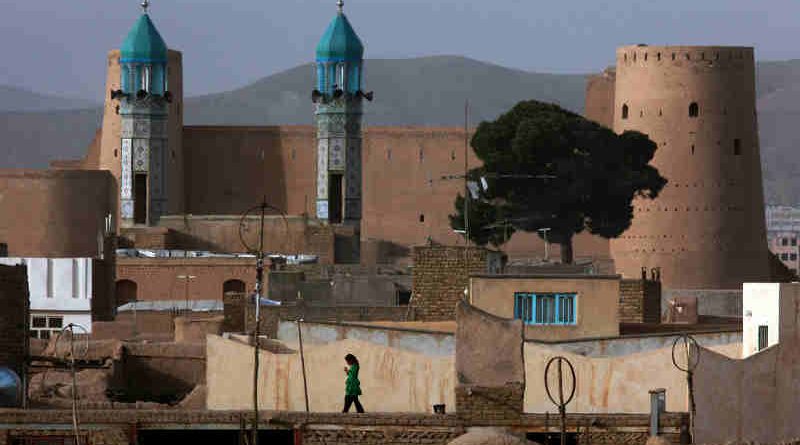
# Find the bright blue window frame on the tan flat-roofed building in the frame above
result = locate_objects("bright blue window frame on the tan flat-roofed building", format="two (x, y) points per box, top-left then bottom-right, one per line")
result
(514, 292), (577, 325)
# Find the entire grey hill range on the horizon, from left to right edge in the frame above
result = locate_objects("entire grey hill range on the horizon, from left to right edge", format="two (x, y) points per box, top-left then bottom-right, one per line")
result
(0, 56), (800, 205)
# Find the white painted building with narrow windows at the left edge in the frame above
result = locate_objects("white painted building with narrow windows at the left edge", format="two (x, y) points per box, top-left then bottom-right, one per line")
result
(0, 258), (92, 338)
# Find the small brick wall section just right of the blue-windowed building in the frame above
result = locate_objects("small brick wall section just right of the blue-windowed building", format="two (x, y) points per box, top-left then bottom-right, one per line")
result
(619, 280), (661, 323)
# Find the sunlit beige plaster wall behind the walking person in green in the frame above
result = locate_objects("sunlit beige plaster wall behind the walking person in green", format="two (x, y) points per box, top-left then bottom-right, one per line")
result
(206, 335), (456, 412)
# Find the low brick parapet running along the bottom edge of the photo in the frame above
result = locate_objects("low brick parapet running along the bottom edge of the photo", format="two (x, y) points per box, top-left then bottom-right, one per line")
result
(0, 410), (688, 445)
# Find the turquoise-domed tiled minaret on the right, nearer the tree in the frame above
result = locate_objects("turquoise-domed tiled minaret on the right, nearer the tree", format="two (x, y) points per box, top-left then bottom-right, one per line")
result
(312, 0), (372, 228)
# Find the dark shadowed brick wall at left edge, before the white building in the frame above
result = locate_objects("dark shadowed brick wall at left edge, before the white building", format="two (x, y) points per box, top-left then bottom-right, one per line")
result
(0, 266), (30, 377)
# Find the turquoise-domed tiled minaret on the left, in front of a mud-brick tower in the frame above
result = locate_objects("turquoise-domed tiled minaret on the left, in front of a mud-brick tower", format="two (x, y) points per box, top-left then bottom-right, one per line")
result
(112, 0), (171, 227)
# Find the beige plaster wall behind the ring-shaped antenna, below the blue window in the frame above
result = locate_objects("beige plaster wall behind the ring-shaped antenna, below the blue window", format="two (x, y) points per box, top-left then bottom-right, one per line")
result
(524, 342), (741, 413)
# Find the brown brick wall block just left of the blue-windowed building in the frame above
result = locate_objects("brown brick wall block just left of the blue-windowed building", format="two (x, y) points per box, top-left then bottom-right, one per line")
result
(411, 246), (489, 321)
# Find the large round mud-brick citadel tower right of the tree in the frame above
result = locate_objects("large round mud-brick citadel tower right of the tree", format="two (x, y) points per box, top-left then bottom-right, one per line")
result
(611, 45), (769, 289)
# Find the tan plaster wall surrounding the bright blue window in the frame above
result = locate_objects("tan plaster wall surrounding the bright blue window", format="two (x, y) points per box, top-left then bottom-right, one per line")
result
(470, 276), (620, 340)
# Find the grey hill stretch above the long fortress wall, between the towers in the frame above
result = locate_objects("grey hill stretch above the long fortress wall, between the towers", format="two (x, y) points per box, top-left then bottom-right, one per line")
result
(185, 56), (586, 125)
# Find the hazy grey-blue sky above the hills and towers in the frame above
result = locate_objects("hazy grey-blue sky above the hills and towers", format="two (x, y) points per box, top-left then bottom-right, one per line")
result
(0, 0), (800, 100)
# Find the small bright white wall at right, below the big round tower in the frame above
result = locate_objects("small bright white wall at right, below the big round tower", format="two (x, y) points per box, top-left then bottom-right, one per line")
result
(742, 283), (781, 358)
